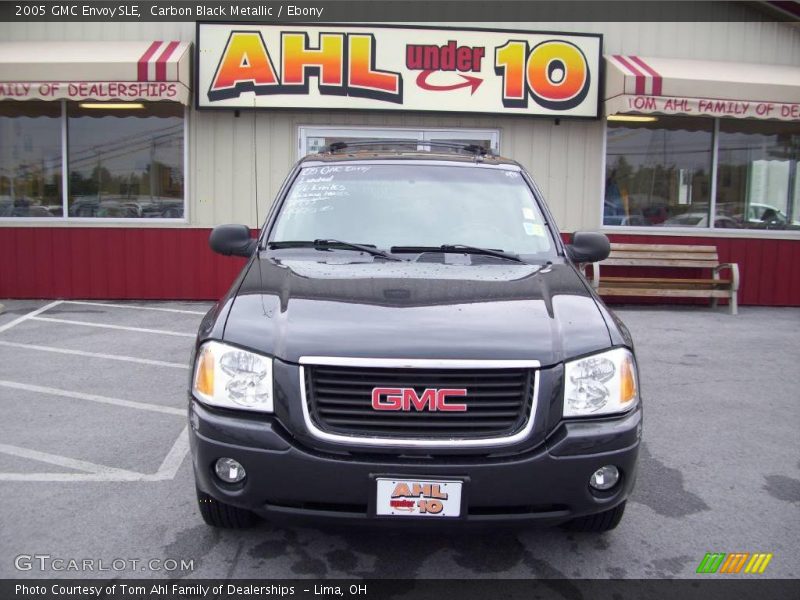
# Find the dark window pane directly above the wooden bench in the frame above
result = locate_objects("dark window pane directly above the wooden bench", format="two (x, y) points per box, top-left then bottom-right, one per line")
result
(603, 117), (720, 227)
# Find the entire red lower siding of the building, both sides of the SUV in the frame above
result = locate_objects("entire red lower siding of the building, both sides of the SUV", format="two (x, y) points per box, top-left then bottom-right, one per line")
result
(0, 227), (800, 306)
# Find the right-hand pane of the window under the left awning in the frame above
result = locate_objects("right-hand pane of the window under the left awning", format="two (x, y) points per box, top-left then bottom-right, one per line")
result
(67, 103), (184, 218)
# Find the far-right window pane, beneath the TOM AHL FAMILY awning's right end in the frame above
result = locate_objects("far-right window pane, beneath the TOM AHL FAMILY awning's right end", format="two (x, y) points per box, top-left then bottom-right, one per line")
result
(716, 119), (800, 230)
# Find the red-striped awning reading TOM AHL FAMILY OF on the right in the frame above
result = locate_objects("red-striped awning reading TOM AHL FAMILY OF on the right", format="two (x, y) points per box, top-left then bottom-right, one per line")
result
(605, 55), (800, 121)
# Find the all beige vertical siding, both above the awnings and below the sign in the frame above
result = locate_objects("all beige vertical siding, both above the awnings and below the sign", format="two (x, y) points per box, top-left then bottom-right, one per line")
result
(0, 12), (800, 231)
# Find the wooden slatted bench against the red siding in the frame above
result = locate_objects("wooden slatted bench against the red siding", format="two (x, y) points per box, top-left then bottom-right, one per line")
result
(587, 244), (739, 315)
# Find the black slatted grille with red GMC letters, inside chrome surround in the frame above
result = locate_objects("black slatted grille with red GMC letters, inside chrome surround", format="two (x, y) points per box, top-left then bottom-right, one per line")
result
(305, 365), (535, 439)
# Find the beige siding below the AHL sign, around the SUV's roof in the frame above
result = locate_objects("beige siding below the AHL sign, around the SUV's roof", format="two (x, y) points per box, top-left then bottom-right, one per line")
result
(190, 111), (603, 230)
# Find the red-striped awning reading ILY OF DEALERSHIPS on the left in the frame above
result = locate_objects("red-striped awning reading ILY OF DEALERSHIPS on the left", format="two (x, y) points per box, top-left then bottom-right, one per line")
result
(0, 41), (191, 104)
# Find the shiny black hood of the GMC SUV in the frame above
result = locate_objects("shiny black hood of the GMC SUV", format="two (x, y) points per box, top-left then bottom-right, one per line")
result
(224, 254), (611, 366)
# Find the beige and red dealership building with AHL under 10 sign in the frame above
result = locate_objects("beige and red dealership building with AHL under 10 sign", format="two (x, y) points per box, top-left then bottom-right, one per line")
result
(0, 8), (800, 306)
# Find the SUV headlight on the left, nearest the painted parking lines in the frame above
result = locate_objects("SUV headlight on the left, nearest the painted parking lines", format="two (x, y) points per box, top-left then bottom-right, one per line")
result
(192, 342), (272, 412)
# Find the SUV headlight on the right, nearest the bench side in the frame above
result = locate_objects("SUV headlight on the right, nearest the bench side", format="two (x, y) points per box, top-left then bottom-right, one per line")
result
(564, 348), (639, 417)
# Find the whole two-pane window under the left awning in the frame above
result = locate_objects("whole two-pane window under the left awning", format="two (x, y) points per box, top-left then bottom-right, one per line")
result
(0, 100), (184, 219)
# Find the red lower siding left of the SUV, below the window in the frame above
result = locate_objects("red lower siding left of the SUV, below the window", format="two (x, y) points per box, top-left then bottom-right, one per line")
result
(0, 227), (245, 300)
